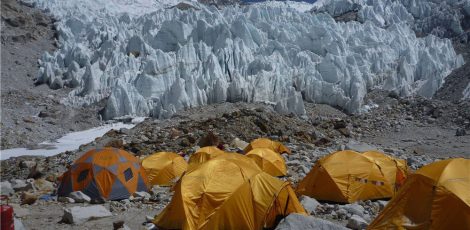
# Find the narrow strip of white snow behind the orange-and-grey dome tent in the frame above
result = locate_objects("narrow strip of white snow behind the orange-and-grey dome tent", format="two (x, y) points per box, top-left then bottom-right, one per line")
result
(0, 122), (136, 160)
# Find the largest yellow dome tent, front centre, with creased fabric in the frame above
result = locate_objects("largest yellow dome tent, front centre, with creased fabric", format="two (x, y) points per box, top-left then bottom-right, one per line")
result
(153, 154), (306, 229)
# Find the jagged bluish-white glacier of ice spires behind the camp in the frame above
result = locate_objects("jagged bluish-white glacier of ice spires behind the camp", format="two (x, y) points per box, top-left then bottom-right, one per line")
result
(29, 0), (463, 119)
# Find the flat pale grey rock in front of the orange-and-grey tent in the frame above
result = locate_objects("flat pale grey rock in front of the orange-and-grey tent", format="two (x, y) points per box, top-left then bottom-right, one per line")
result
(62, 205), (113, 224)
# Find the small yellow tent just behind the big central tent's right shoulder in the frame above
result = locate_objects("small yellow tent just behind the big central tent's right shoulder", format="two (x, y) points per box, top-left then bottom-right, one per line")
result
(246, 148), (287, 176)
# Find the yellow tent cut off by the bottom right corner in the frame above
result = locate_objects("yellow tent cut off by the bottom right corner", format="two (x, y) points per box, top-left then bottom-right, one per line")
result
(369, 158), (470, 229)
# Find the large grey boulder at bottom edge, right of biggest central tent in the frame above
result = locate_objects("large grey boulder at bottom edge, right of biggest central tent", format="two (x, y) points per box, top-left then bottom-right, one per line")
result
(276, 213), (347, 230)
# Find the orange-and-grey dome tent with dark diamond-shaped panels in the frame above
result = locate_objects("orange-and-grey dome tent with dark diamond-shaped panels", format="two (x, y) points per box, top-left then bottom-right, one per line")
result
(57, 148), (148, 200)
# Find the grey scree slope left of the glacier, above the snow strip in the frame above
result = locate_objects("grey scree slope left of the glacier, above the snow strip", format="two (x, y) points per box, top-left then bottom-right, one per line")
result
(0, 0), (100, 149)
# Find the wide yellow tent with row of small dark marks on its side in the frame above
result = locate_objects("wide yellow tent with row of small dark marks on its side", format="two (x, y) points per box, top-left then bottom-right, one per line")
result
(297, 150), (407, 203)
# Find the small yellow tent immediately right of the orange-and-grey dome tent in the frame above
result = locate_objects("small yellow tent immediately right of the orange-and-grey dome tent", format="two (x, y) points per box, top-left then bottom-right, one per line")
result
(142, 152), (188, 186)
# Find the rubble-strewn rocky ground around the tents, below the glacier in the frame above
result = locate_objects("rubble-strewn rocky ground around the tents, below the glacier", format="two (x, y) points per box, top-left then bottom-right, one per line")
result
(0, 91), (470, 229)
